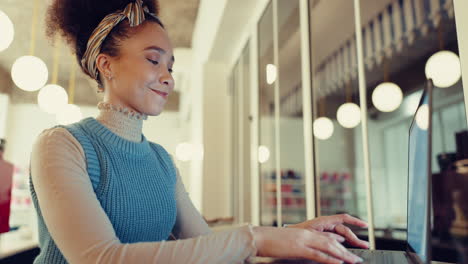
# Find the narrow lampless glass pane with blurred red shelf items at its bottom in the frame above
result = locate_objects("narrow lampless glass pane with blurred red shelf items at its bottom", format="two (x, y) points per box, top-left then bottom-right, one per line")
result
(277, 0), (306, 224)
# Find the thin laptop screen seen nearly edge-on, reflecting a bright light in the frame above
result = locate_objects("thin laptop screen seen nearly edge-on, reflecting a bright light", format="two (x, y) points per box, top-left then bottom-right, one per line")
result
(408, 84), (432, 263)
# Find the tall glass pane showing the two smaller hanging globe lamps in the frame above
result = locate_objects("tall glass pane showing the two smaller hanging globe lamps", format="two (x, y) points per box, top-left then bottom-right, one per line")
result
(309, 0), (367, 219)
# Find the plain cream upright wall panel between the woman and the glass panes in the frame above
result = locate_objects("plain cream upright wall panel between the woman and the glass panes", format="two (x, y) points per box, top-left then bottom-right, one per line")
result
(202, 63), (233, 218)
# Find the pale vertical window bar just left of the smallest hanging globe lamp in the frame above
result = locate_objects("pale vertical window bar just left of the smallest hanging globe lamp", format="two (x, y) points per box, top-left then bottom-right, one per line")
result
(299, 0), (317, 219)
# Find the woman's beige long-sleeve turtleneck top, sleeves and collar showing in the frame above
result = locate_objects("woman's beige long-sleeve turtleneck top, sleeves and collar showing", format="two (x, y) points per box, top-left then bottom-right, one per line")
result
(31, 102), (257, 264)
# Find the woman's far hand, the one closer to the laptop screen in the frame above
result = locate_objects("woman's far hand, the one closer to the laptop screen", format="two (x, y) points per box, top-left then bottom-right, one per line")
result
(288, 214), (369, 248)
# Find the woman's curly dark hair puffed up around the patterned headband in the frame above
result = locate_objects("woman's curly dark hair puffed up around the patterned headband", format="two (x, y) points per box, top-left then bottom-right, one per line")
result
(46, 0), (164, 86)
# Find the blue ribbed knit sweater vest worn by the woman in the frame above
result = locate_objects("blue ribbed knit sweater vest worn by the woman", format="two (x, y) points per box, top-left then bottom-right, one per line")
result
(30, 118), (177, 264)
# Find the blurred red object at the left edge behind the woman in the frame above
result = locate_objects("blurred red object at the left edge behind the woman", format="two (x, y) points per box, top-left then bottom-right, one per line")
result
(0, 157), (14, 234)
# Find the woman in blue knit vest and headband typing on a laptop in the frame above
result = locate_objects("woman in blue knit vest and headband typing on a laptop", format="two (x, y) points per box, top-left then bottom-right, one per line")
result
(31, 0), (368, 264)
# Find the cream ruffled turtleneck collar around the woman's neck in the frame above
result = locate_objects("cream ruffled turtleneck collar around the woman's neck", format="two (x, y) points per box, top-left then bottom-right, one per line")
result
(96, 102), (148, 142)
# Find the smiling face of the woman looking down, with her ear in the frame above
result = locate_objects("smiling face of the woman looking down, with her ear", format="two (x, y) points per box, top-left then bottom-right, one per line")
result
(97, 21), (174, 116)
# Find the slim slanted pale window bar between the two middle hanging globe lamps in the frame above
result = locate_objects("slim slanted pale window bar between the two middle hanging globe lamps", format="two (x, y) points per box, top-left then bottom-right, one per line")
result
(354, 0), (375, 249)
